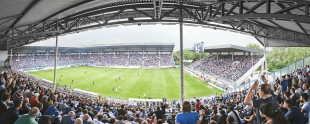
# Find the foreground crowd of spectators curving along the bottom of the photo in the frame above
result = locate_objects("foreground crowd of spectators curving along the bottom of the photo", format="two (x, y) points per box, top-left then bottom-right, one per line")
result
(0, 56), (310, 124)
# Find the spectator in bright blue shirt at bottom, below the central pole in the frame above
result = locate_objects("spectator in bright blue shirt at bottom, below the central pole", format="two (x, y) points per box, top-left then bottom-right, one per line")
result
(175, 101), (200, 124)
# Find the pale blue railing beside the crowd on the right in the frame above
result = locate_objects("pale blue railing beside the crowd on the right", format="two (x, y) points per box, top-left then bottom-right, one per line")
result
(224, 56), (310, 94)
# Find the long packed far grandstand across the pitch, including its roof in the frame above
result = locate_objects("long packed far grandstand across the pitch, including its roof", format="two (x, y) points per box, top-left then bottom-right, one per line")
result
(12, 44), (175, 71)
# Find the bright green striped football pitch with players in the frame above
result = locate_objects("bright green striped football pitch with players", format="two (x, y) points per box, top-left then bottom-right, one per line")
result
(29, 66), (222, 99)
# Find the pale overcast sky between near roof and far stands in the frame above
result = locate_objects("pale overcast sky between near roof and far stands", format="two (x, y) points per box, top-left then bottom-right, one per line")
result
(30, 24), (262, 50)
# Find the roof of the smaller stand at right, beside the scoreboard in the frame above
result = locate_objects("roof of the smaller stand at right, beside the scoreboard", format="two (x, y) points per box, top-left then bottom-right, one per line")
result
(204, 44), (264, 53)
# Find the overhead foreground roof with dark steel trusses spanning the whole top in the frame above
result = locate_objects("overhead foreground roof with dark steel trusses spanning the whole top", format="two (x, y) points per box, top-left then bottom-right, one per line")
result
(0, 0), (310, 48)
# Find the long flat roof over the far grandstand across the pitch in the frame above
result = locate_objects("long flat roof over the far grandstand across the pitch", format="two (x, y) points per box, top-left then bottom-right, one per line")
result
(13, 43), (174, 54)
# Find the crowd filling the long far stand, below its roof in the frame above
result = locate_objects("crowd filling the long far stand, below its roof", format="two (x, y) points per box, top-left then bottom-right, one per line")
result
(11, 53), (174, 70)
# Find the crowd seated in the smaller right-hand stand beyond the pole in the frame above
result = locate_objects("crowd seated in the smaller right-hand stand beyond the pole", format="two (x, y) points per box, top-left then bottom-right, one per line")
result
(189, 55), (262, 80)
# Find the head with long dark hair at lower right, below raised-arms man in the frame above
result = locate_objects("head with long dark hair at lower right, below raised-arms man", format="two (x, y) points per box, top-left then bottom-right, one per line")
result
(259, 103), (288, 124)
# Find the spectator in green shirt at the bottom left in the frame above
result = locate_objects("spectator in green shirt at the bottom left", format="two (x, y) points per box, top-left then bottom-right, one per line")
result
(14, 107), (39, 124)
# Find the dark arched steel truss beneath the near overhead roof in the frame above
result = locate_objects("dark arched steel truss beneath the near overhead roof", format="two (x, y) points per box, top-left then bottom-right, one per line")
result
(0, 0), (310, 48)
